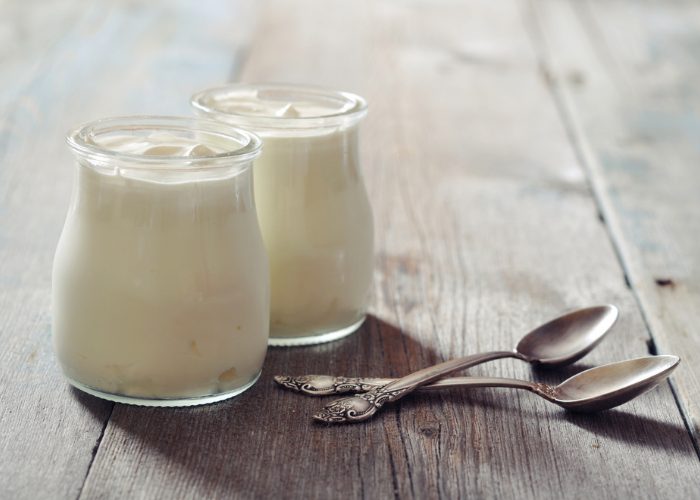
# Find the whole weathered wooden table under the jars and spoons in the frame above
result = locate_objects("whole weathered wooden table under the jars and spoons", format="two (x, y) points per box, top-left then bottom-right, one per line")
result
(0, 0), (700, 499)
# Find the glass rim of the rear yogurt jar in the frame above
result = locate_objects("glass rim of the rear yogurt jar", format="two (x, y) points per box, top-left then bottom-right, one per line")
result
(190, 83), (368, 130)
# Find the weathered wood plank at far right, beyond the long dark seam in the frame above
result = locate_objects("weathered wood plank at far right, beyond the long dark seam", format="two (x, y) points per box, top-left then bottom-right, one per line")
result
(535, 1), (700, 439)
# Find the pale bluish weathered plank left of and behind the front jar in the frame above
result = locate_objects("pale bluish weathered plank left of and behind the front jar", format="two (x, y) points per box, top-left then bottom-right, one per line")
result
(0, 1), (252, 499)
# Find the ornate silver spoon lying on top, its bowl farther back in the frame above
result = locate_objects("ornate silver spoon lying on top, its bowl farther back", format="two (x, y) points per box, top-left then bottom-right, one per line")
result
(306, 305), (618, 418)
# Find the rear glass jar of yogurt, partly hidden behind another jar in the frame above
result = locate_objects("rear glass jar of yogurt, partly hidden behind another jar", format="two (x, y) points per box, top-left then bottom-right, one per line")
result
(192, 84), (374, 346)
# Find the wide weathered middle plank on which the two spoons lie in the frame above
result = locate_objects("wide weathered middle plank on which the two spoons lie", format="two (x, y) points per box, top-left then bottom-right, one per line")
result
(83, 1), (700, 498)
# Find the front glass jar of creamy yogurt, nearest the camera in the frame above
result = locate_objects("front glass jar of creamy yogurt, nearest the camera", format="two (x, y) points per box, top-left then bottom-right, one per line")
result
(52, 117), (269, 406)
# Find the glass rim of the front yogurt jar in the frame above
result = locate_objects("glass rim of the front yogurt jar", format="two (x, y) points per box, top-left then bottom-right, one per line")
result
(66, 115), (262, 170)
